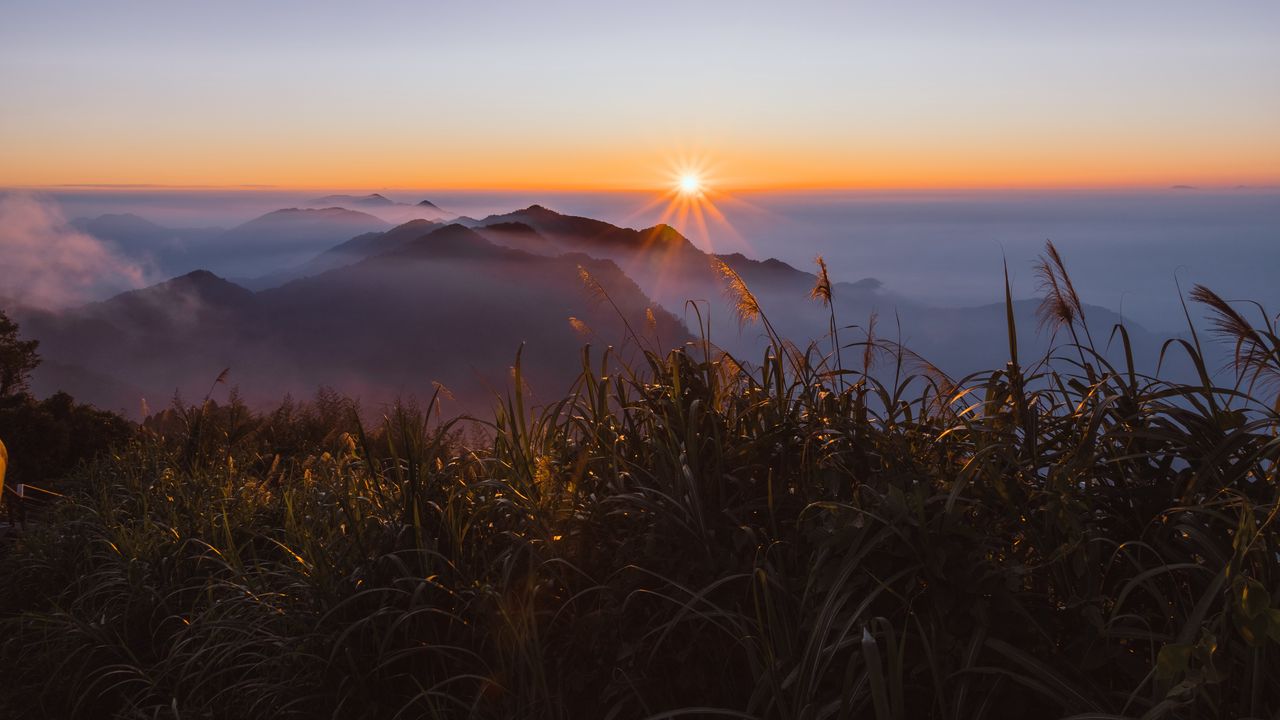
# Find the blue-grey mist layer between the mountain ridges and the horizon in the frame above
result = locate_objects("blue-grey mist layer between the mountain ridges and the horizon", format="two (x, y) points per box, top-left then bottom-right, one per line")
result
(42, 183), (1280, 332)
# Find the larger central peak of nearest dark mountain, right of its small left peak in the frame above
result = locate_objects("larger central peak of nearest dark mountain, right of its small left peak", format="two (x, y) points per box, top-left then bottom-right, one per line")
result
(252, 224), (687, 407)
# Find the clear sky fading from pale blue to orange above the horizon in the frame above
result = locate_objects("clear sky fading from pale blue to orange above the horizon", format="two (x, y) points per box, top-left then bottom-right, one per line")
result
(0, 0), (1280, 190)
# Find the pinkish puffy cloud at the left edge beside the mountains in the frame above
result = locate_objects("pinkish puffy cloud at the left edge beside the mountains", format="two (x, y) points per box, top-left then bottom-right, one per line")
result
(0, 193), (143, 309)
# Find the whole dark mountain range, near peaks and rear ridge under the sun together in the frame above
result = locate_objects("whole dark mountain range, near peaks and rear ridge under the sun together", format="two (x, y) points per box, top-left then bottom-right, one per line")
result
(30, 205), (1182, 413)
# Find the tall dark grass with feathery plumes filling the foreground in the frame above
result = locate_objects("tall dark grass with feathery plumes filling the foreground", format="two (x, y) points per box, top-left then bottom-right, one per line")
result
(0, 248), (1280, 720)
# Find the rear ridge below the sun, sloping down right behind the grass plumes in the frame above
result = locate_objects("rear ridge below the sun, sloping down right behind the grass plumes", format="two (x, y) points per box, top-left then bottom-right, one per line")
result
(460, 205), (1177, 374)
